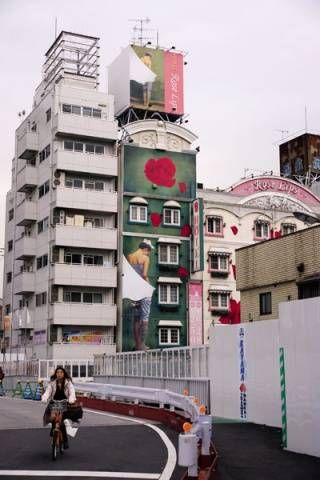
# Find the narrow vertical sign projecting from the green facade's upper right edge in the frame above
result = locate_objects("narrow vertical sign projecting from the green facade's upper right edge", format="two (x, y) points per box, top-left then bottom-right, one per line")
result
(192, 198), (203, 272)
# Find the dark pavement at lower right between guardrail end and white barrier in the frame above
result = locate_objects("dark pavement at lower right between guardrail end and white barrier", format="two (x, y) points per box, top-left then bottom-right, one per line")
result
(213, 418), (320, 480)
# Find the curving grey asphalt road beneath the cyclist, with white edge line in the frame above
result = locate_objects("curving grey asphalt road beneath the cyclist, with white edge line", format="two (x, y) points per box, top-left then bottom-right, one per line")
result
(0, 397), (184, 480)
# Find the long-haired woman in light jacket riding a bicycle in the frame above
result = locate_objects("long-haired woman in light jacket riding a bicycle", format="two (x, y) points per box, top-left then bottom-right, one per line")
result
(41, 367), (76, 449)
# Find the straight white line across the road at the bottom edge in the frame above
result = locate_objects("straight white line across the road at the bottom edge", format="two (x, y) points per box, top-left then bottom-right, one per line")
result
(0, 470), (161, 480)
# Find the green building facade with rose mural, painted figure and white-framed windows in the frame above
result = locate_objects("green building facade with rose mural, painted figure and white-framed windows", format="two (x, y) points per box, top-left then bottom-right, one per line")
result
(122, 145), (196, 350)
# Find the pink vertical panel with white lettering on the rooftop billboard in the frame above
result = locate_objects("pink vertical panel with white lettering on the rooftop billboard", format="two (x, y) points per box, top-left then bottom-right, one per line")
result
(164, 52), (183, 115)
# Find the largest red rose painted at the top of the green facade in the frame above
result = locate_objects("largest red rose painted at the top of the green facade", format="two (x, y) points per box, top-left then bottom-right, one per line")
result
(144, 157), (176, 188)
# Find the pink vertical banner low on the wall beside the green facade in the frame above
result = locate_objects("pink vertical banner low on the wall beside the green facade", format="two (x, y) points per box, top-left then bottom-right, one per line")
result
(188, 282), (203, 346)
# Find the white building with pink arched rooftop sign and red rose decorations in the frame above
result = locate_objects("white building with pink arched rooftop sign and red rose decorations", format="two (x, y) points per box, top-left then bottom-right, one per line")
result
(191, 175), (320, 343)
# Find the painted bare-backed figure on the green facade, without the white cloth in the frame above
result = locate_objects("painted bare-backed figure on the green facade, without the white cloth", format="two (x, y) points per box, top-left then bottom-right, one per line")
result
(127, 239), (154, 350)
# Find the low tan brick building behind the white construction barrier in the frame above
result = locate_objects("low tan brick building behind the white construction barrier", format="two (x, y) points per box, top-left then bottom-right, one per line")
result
(236, 225), (320, 322)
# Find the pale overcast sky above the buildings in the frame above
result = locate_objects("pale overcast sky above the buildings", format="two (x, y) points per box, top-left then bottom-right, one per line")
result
(0, 0), (320, 292)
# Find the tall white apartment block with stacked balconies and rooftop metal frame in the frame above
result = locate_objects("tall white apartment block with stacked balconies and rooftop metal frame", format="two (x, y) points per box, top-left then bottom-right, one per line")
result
(3, 32), (118, 359)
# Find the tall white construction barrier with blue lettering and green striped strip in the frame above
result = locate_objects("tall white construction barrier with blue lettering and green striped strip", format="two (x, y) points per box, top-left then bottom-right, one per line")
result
(209, 297), (320, 456)
